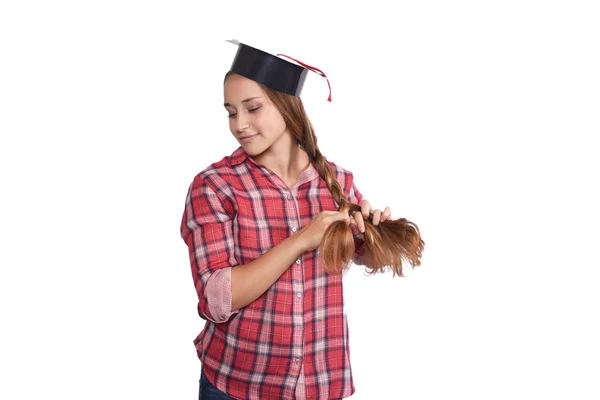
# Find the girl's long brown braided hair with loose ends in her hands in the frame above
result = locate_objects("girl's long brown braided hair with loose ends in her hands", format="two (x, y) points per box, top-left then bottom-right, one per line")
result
(225, 72), (425, 276)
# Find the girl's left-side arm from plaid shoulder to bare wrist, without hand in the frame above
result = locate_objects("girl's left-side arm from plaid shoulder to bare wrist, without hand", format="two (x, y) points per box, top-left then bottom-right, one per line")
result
(181, 176), (304, 323)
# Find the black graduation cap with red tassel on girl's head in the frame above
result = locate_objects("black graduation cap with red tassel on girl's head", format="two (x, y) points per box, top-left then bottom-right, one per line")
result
(228, 40), (331, 101)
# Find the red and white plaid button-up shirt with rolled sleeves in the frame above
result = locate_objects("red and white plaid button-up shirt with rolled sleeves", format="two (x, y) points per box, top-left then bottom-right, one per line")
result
(181, 146), (364, 400)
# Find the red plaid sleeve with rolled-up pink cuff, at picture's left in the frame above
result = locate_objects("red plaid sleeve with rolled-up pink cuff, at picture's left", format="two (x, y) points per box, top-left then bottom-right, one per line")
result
(181, 175), (239, 323)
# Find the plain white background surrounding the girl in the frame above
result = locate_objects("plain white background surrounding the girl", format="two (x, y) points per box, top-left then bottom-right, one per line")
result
(0, 0), (600, 400)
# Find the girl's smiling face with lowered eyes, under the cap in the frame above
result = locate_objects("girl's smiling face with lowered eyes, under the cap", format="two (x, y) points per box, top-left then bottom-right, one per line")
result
(225, 74), (286, 155)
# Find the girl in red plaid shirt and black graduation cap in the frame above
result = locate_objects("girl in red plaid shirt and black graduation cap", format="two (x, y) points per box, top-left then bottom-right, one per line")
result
(181, 42), (410, 400)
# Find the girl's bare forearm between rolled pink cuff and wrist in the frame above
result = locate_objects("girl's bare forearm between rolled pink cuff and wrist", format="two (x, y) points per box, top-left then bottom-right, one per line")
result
(231, 235), (304, 310)
